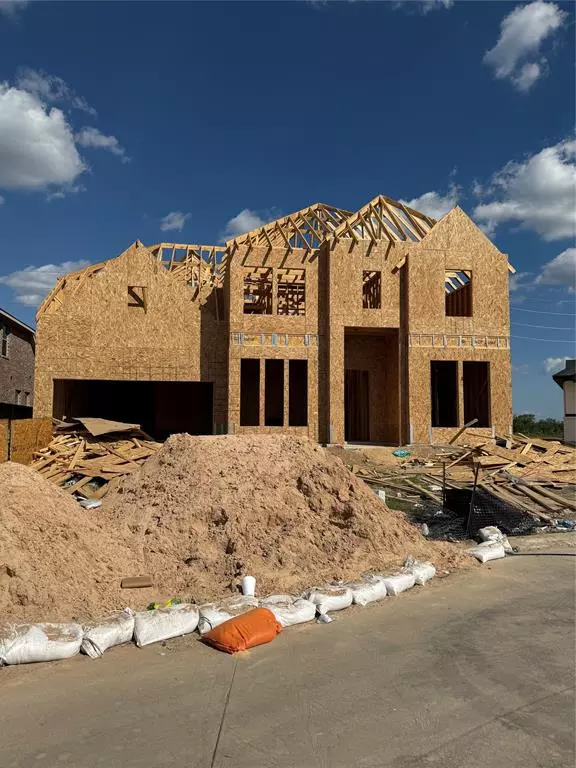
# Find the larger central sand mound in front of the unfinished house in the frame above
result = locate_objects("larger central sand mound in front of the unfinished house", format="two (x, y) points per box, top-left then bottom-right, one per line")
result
(103, 435), (463, 601)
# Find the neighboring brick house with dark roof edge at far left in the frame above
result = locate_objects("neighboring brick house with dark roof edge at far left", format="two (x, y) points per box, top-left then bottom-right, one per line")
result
(0, 309), (35, 419)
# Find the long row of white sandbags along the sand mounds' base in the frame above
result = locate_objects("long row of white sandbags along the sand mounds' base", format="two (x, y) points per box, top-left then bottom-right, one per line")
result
(0, 558), (436, 666)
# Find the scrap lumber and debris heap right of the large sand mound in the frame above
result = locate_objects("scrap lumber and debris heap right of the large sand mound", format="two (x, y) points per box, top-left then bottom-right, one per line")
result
(344, 430), (576, 538)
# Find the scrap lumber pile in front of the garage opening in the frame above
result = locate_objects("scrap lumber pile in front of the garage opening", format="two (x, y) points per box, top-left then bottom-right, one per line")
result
(30, 419), (162, 500)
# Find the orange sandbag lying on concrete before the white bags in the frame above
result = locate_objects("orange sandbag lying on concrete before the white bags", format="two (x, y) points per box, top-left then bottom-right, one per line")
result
(202, 608), (282, 653)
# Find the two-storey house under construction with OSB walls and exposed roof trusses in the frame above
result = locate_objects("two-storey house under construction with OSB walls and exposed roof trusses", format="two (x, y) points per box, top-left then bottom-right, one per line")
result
(34, 196), (513, 444)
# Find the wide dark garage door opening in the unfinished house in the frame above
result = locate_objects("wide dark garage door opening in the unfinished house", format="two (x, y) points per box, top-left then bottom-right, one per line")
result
(53, 379), (213, 440)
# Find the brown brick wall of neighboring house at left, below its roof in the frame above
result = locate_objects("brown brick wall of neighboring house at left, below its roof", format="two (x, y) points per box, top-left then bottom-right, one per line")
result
(0, 315), (34, 406)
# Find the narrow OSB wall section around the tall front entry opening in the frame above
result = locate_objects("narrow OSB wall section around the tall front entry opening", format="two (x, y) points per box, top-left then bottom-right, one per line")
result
(321, 239), (405, 443)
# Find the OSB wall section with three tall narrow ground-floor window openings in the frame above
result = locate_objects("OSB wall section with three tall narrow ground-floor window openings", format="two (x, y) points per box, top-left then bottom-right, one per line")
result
(226, 246), (322, 440)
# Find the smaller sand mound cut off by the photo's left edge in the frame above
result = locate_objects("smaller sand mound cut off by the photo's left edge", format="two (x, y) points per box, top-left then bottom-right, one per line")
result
(0, 462), (148, 621)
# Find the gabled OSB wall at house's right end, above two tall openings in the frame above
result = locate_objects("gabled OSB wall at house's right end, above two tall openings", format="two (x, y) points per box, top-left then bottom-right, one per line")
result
(403, 208), (512, 442)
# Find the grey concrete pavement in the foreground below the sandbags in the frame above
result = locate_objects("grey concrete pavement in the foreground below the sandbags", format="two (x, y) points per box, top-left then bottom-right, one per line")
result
(0, 544), (575, 768)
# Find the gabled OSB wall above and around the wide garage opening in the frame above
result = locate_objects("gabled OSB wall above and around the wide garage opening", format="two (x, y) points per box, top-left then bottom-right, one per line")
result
(34, 244), (227, 423)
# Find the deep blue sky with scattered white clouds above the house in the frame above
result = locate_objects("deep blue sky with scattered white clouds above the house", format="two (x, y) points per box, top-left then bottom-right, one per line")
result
(0, 0), (576, 416)
